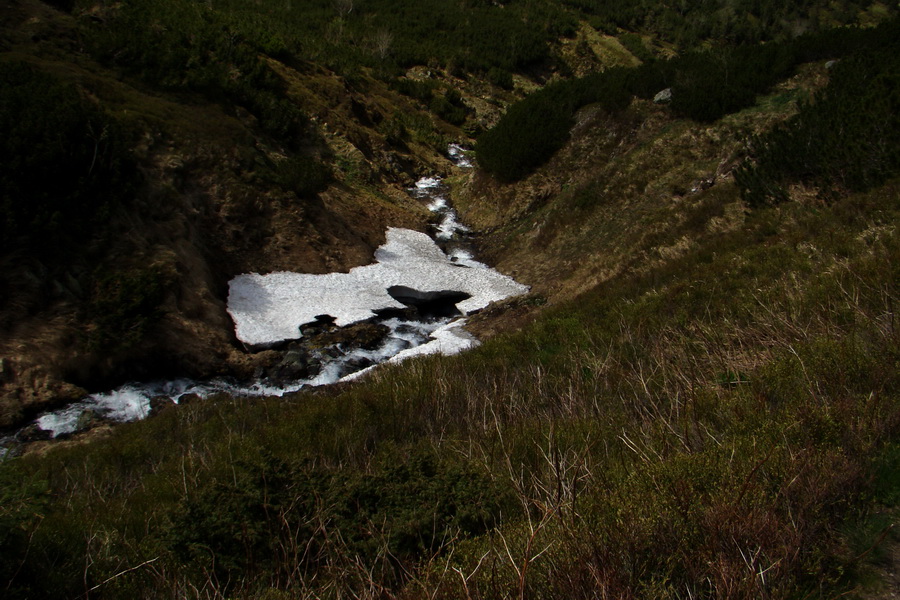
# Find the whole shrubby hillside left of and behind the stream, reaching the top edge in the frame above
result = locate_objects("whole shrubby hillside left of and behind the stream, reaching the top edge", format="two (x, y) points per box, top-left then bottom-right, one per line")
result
(0, 0), (890, 426)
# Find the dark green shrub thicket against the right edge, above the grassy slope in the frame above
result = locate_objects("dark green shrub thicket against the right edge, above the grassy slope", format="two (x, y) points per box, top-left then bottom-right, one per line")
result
(736, 21), (900, 206)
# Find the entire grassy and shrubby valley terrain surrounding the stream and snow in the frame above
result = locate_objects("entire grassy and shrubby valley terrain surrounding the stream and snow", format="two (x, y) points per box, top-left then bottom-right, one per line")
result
(0, 0), (900, 600)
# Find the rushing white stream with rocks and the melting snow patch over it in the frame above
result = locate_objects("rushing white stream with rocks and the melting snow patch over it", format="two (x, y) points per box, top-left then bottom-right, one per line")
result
(0, 145), (528, 453)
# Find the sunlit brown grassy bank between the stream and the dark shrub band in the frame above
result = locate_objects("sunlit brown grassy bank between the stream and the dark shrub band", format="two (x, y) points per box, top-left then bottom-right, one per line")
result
(455, 64), (826, 328)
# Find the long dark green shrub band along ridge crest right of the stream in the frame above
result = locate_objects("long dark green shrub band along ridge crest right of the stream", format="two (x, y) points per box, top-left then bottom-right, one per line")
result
(477, 20), (896, 181)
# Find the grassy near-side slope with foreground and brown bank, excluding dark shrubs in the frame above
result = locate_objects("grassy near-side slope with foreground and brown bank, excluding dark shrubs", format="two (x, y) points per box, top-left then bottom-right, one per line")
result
(2, 50), (900, 598)
